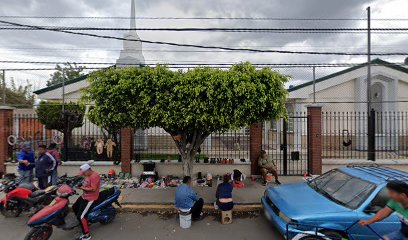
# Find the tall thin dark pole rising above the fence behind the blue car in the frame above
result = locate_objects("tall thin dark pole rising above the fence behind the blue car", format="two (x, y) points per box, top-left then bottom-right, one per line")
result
(367, 7), (375, 161)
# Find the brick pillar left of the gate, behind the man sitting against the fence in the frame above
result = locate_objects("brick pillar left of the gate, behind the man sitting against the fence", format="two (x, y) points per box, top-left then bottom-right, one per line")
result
(249, 123), (262, 175)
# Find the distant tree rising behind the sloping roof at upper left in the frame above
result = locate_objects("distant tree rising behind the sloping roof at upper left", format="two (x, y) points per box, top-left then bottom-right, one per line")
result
(47, 62), (84, 87)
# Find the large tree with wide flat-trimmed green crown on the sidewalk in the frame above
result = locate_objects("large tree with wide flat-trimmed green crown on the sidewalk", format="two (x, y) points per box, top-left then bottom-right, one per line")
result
(83, 63), (289, 175)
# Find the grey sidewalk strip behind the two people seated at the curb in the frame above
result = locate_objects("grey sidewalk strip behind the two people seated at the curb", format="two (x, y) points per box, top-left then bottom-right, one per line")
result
(121, 176), (304, 206)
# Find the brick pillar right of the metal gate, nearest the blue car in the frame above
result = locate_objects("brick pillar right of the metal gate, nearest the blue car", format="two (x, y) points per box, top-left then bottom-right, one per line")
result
(307, 105), (322, 175)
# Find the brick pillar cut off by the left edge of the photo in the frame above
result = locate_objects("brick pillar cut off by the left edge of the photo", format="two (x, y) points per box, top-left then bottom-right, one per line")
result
(0, 106), (14, 177)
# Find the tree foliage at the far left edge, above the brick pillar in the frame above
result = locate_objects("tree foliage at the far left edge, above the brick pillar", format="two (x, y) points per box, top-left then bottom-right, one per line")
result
(0, 73), (35, 108)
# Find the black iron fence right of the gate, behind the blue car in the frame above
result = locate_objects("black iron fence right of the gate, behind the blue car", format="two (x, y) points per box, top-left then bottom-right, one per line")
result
(322, 112), (408, 159)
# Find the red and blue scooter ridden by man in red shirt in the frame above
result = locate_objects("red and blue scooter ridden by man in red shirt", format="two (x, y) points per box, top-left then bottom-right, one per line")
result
(25, 184), (121, 240)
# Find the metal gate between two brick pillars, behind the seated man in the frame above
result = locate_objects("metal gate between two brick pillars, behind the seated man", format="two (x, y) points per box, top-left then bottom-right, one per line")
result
(263, 113), (308, 175)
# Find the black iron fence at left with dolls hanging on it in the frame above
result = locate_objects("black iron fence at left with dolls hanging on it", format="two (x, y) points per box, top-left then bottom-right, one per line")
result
(7, 110), (120, 162)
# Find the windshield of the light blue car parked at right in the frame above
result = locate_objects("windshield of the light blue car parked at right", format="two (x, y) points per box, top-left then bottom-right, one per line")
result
(309, 170), (375, 209)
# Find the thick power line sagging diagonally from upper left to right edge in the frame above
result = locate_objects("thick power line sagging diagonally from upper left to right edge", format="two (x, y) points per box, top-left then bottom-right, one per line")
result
(0, 20), (408, 56)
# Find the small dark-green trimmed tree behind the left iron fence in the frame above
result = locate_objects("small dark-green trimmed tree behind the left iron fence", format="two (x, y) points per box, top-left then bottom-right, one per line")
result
(36, 101), (85, 145)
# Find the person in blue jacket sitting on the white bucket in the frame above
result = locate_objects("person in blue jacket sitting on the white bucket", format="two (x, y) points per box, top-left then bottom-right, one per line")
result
(175, 176), (204, 221)
